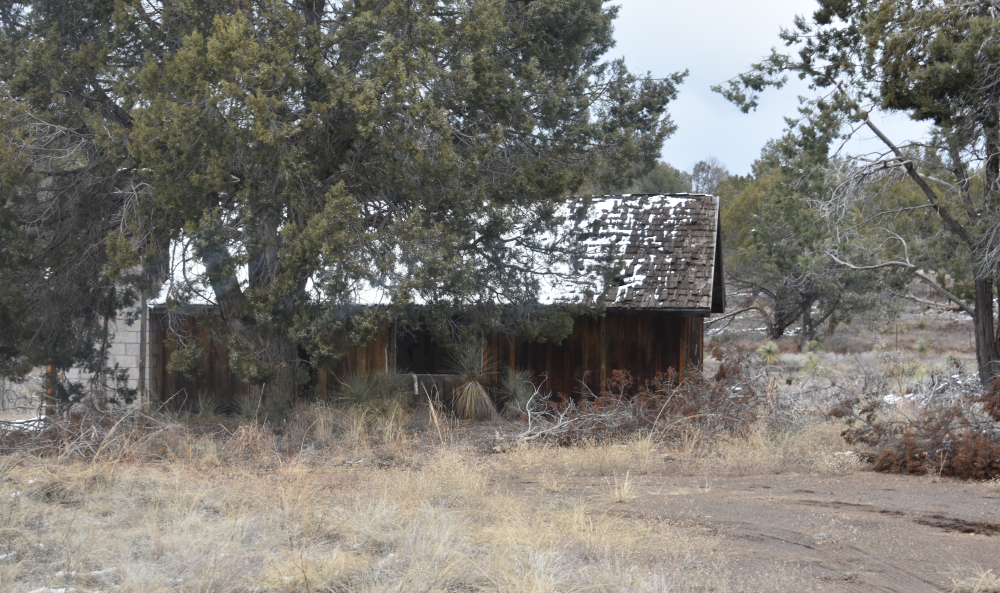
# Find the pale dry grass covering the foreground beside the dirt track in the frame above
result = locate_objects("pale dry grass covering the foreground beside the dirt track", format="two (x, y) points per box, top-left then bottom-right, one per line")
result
(0, 394), (876, 593)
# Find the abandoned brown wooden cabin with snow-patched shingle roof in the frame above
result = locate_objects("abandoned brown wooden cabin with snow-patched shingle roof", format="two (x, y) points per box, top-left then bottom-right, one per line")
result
(149, 194), (725, 406)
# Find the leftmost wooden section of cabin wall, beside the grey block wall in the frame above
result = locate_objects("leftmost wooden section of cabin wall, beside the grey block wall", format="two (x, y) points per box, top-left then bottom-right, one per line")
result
(150, 310), (249, 411)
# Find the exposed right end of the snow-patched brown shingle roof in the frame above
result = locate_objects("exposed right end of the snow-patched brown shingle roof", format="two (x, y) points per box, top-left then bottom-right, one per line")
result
(544, 194), (725, 315)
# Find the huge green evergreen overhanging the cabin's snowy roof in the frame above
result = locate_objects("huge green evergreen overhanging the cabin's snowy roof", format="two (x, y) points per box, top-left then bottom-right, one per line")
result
(0, 0), (684, 400)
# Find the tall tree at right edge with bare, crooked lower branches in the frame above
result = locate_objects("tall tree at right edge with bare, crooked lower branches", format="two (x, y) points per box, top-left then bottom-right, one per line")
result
(716, 0), (1000, 386)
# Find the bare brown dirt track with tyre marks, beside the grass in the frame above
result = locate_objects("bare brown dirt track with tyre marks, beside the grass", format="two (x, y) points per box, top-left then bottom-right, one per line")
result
(500, 462), (1000, 592)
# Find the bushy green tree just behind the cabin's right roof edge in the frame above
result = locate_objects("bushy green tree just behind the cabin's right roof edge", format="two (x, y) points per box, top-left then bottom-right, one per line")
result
(722, 138), (884, 347)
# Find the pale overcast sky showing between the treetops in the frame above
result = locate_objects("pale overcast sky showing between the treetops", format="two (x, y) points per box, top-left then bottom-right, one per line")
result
(612, 0), (925, 174)
